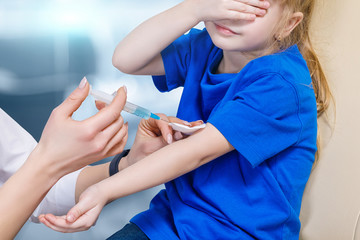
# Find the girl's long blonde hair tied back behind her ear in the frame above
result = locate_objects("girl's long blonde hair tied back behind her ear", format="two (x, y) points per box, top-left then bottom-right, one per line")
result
(275, 0), (334, 162)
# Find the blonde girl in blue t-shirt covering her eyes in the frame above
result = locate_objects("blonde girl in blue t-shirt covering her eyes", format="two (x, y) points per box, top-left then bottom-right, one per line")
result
(40, 0), (331, 240)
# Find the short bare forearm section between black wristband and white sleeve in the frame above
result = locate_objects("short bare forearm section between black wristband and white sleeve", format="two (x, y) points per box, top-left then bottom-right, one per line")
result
(75, 163), (110, 202)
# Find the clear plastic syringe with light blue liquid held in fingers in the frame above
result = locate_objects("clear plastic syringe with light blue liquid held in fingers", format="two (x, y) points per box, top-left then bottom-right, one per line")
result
(89, 87), (161, 120)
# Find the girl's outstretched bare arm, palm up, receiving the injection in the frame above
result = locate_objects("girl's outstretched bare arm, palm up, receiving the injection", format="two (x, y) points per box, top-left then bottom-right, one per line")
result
(41, 124), (233, 232)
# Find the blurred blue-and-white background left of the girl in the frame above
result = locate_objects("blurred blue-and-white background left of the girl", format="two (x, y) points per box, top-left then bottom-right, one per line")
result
(0, 0), (181, 240)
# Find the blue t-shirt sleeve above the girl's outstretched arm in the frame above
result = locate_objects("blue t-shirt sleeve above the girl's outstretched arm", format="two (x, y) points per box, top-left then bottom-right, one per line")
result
(208, 74), (302, 167)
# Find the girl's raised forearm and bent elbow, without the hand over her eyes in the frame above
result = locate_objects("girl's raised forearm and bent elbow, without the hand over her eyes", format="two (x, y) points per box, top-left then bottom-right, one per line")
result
(113, 1), (199, 75)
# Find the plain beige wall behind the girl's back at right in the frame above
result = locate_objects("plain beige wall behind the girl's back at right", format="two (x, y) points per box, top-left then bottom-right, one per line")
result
(301, 0), (360, 240)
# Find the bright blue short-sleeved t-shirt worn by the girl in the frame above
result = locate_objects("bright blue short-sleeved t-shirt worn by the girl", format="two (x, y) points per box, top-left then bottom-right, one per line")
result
(131, 29), (317, 240)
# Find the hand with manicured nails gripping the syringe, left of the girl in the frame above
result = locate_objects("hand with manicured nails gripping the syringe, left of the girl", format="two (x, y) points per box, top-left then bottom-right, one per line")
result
(35, 78), (128, 178)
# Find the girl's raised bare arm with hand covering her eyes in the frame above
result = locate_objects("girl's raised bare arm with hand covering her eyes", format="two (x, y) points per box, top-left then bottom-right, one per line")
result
(113, 0), (269, 75)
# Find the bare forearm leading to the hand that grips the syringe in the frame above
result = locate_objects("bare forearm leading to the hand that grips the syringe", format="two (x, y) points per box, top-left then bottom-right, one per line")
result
(0, 151), (58, 239)
